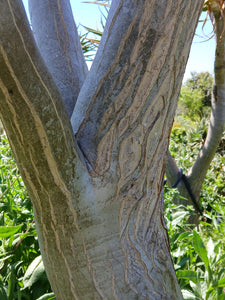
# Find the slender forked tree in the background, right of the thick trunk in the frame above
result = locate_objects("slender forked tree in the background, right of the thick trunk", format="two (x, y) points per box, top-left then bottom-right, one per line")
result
(166, 0), (225, 220)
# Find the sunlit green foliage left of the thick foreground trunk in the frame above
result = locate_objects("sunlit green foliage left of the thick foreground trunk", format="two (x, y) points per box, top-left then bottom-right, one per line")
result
(0, 134), (55, 300)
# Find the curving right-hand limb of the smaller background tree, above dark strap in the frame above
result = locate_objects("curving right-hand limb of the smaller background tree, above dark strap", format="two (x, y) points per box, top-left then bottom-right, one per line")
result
(188, 4), (225, 199)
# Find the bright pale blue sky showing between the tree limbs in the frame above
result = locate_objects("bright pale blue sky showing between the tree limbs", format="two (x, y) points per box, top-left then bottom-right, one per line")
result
(23, 0), (215, 80)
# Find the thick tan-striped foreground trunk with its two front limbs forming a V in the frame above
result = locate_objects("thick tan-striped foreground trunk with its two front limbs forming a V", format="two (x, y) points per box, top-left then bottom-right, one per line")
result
(0, 0), (202, 300)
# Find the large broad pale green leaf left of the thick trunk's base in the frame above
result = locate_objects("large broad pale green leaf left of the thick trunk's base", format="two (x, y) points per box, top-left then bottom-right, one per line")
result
(23, 255), (45, 289)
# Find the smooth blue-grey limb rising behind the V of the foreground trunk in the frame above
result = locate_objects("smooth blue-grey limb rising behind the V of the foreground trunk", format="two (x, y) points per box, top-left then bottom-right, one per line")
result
(29, 0), (87, 117)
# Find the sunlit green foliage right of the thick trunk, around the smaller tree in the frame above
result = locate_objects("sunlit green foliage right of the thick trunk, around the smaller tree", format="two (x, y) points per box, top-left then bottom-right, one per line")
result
(164, 74), (225, 300)
